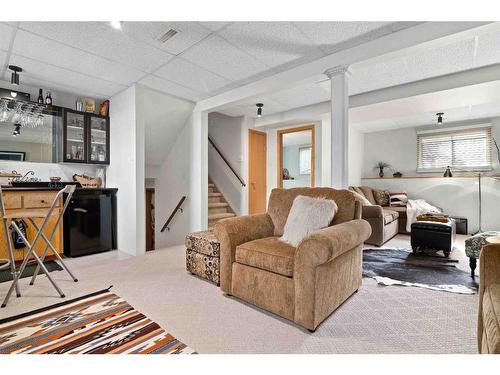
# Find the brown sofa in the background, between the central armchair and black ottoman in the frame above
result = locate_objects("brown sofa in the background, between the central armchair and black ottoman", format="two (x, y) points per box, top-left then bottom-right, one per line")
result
(349, 186), (408, 246)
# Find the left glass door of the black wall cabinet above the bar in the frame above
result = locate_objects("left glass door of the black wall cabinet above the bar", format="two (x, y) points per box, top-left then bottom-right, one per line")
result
(64, 111), (86, 162)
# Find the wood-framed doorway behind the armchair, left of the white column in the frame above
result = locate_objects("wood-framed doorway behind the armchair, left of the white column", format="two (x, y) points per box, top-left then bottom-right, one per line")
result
(277, 125), (315, 189)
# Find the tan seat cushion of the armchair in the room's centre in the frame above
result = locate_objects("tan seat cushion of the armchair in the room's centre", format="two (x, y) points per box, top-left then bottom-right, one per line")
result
(235, 237), (295, 277)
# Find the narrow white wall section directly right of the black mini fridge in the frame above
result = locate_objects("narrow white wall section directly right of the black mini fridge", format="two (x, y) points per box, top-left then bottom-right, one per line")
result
(107, 86), (146, 255)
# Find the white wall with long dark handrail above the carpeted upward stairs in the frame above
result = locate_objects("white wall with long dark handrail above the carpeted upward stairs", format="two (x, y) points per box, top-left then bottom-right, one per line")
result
(208, 112), (251, 215)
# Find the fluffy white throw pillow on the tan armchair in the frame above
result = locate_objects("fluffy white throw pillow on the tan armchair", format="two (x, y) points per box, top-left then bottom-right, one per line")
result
(280, 195), (338, 247)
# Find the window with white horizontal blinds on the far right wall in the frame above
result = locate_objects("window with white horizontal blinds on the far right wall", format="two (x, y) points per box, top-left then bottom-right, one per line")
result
(417, 128), (492, 172)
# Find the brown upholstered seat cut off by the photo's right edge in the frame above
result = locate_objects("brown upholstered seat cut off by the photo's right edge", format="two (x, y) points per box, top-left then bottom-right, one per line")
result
(477, 244), (500, 354)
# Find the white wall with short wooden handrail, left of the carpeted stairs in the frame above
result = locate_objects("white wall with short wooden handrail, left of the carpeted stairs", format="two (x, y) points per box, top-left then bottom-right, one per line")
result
(155, 112), (208, 248)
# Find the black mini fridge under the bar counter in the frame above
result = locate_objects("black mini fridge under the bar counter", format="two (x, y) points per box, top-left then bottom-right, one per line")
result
(64, 189), (116, 257)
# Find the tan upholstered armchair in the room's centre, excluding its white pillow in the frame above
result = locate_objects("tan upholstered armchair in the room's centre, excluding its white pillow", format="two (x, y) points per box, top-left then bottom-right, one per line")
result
(214, 188), (371, 331)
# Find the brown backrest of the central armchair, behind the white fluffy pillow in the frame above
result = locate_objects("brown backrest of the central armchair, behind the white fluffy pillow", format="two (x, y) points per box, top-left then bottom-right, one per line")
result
(267, 187), (361, 236)
